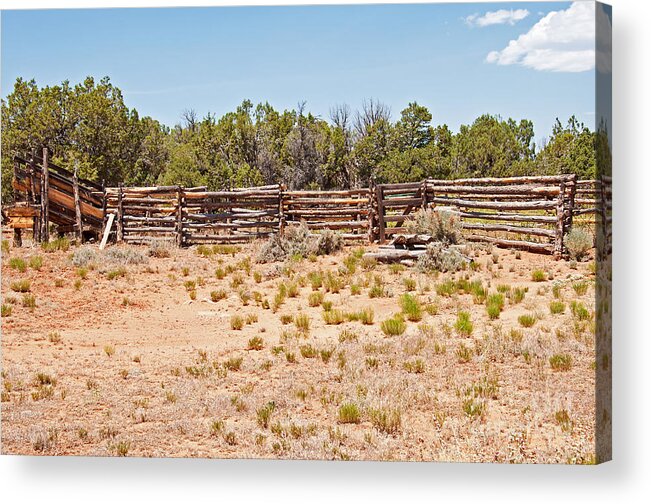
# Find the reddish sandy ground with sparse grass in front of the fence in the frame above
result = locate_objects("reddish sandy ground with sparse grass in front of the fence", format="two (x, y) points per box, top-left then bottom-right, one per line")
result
(1, 238), (595, 463)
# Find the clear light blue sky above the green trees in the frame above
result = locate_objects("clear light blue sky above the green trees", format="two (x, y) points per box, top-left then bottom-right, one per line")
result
(1, 2), (595, 146)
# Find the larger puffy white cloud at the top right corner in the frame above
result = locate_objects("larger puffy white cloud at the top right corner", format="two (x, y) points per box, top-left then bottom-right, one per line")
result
(486, 2), (595, 72)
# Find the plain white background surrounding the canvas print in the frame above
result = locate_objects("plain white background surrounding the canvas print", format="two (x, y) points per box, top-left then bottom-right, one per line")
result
(0, 0), (651, 504)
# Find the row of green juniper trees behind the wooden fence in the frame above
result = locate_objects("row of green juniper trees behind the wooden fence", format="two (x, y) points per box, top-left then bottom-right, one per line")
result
(2, 77), (597, 203)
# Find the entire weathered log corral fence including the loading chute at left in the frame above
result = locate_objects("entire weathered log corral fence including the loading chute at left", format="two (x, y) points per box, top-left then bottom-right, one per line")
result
(3, 145), (612, 257)
